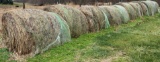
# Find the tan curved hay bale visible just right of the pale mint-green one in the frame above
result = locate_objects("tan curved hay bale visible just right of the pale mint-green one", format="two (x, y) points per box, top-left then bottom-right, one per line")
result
(116, 3), (137, 20)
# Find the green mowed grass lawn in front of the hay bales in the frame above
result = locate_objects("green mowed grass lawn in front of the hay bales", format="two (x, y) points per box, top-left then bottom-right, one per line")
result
(0, 14), (160, 62)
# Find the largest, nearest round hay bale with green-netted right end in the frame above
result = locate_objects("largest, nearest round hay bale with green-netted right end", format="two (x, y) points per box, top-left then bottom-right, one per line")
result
(2, 9), (71, 55)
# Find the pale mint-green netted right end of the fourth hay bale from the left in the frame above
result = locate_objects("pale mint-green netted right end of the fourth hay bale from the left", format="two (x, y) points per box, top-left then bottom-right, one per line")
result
(114, 5), (130, 23)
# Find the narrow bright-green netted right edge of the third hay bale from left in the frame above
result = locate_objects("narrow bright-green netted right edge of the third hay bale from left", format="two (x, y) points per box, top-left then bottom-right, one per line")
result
(99, 6), (110, 28)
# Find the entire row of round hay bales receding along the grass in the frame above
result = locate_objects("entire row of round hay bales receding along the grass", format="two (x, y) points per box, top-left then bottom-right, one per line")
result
(2, 1), (159, 55)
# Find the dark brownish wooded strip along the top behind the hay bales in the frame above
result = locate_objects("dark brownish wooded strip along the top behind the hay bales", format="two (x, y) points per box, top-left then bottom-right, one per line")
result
(3, 0), (160, 5)
